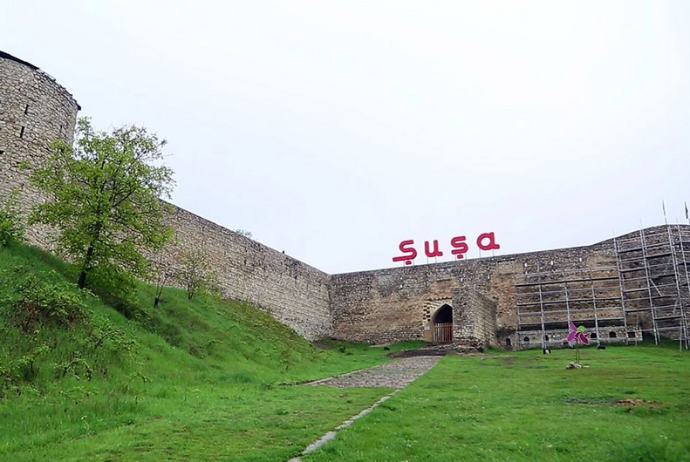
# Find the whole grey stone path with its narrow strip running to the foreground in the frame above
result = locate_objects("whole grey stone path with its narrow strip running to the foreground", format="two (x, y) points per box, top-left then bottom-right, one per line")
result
(288, 356), (441, 462)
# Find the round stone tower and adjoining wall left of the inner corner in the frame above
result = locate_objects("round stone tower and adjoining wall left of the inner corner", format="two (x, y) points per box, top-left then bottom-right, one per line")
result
(0, 52), (331, 339)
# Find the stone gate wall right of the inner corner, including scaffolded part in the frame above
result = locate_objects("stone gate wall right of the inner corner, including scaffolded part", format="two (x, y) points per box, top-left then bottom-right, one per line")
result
(330, 225), (690, 349)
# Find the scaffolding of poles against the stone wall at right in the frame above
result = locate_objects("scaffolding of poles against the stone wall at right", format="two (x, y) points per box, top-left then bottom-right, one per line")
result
(515, 225), (690, 349)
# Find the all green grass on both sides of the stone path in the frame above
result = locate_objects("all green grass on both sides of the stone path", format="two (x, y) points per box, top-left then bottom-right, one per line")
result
(0, 246), (690, 462)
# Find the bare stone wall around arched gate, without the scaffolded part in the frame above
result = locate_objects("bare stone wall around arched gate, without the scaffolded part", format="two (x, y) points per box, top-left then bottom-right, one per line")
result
(330, 241), (615, 344)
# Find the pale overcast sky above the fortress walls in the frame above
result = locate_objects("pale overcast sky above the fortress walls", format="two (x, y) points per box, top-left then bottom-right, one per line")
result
(0, 0), (690, 273)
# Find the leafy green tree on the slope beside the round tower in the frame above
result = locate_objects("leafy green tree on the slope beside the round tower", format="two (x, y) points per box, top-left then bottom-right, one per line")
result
(31, 119), (174, 288)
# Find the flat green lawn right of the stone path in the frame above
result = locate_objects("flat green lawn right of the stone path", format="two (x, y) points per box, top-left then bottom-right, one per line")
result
(304, 345), (690, 462)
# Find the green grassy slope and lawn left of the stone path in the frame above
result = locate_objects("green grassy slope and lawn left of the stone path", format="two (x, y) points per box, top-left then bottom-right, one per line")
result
(0, 244), (404, 460)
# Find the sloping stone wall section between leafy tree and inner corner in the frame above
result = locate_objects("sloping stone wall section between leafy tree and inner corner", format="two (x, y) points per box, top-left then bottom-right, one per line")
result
(159, 207), (331, 340)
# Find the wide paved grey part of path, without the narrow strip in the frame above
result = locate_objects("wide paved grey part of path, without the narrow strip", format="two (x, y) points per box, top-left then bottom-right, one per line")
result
(311, 356), (441, 388)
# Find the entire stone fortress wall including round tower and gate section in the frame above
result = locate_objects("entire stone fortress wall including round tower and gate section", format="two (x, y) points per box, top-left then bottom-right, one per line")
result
(0, 52), (690, 348)
